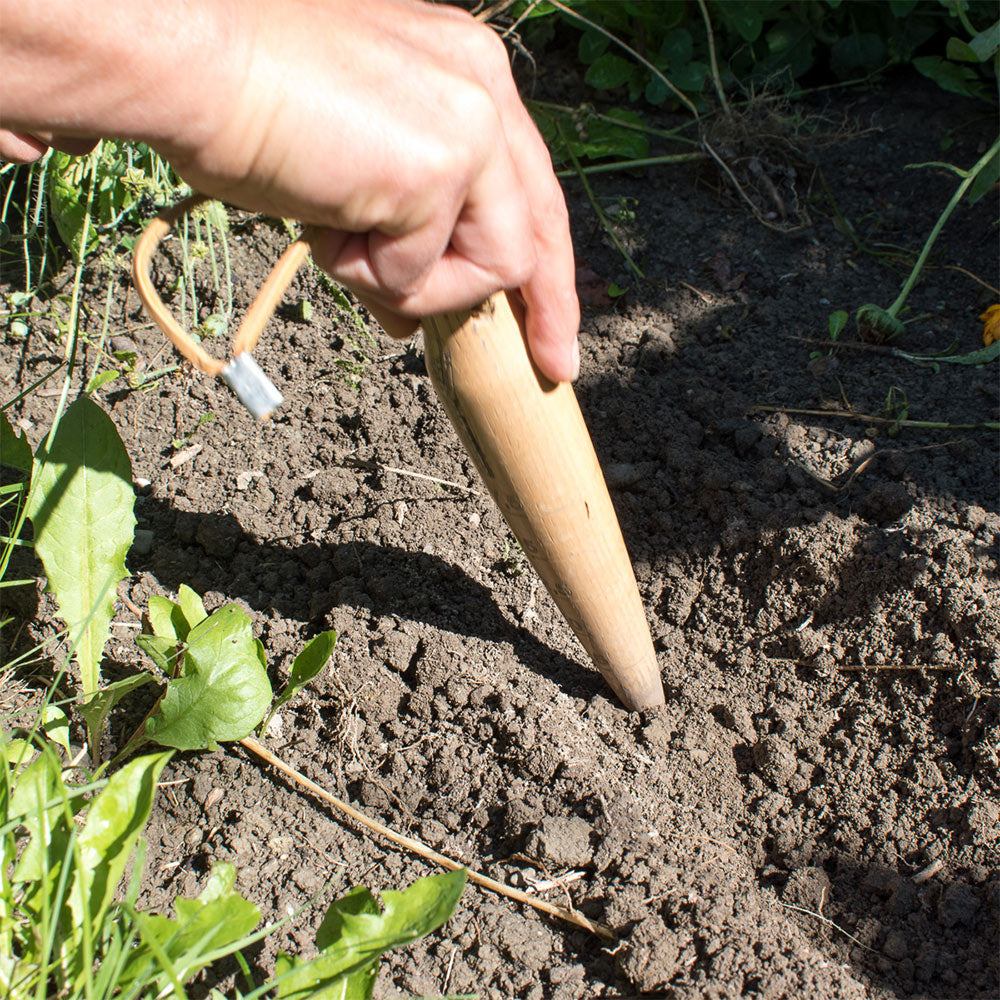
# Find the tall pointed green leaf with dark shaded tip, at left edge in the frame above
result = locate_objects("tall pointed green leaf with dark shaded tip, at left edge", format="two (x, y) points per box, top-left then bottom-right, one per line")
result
(28, 396), (135, 696)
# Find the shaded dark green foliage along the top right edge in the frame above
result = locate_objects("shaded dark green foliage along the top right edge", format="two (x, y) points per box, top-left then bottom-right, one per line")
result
(519, 0), (1000, 108)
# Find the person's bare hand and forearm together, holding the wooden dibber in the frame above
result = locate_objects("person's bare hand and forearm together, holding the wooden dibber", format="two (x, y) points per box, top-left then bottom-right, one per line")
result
(0, 0), (579, 381)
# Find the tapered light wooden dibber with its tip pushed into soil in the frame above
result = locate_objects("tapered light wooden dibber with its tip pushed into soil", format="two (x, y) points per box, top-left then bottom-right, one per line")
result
(423, 292), (664, 709)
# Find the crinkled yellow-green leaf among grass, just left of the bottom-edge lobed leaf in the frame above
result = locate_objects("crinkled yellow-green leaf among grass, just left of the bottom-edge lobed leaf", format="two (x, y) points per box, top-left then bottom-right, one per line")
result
(118, 861), (260, 988)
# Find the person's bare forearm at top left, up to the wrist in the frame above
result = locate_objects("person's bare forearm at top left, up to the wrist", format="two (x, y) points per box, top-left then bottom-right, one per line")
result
(0, 0), (250, 150)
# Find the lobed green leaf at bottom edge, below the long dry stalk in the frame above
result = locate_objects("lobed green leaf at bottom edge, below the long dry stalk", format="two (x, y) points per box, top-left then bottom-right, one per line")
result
(275, 869), (465, 1000)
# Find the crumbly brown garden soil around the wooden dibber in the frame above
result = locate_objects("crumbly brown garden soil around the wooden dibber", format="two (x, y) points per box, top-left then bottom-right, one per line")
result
(0, 68), (1000, 1000)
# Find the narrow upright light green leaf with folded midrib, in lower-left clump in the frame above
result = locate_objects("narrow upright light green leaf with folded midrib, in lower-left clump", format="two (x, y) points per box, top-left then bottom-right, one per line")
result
(69, 752), (171, 957)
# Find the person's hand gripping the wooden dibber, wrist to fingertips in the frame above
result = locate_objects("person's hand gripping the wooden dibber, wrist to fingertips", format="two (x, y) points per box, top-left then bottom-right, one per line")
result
(162, 0), (579, 381)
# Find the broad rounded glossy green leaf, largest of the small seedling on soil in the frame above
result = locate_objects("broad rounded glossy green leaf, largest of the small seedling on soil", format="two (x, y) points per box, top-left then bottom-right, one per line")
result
(146, 604), (271, 750)
